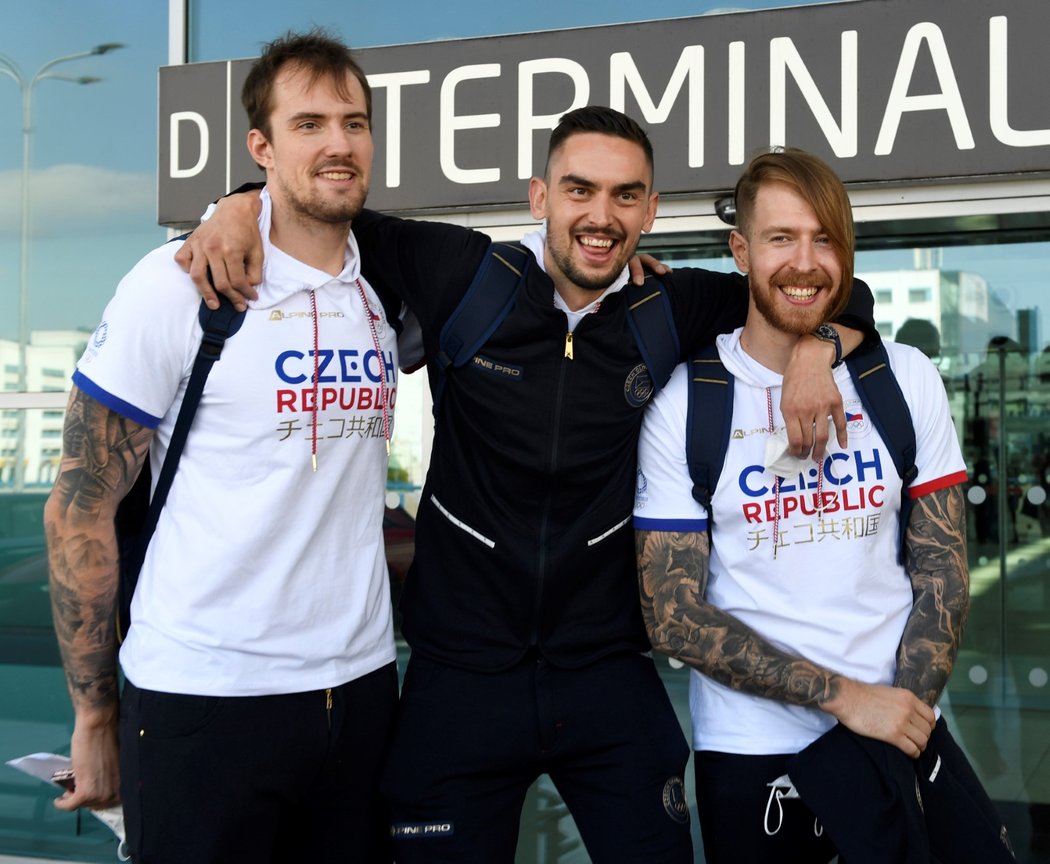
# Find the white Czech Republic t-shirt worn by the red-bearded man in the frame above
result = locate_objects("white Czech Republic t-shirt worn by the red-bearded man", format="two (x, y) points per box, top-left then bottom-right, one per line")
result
(634, 330), (966, 754)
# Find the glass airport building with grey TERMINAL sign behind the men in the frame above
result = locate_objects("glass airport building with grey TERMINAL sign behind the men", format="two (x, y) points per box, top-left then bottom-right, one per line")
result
(0, 0), (1050, 864)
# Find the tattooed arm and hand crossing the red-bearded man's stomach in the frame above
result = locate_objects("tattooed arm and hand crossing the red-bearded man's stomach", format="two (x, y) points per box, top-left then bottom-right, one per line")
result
(635, 530), (933, 757)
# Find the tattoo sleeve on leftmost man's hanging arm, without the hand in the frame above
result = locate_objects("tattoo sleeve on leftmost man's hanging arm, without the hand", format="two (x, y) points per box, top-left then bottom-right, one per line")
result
(44, 391), (152, 707)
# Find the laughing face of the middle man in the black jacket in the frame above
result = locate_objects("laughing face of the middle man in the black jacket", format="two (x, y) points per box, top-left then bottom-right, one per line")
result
(529, 132), (658, 309)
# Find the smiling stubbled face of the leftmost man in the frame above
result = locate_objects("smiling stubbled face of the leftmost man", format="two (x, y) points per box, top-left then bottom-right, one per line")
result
(248, 64), (373, 226)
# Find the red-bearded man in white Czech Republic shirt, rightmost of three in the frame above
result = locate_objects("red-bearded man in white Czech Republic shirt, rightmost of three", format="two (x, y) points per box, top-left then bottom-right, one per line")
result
(634, 148), (1007, 864)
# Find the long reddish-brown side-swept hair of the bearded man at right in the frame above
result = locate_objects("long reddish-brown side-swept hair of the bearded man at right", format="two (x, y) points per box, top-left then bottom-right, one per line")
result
(734, 147), (855, 320)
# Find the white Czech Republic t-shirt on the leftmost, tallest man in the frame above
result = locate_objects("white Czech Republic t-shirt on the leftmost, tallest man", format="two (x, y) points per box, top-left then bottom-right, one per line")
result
(74, 191), (397, 696)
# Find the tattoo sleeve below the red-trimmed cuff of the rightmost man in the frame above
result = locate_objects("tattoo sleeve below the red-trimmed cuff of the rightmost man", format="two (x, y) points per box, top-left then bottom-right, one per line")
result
(894, 486), (969, 705)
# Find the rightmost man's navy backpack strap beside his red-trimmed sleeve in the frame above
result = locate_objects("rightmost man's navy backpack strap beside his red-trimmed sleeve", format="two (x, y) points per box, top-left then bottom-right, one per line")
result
(845, 341), (919, 565)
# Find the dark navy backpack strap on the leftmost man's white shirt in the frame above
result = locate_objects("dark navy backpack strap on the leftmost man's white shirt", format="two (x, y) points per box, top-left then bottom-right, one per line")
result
(116, 296), (245, 640)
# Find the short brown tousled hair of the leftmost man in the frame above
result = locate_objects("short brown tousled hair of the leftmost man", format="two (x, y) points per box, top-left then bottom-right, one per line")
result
(240, 27), (372, 139)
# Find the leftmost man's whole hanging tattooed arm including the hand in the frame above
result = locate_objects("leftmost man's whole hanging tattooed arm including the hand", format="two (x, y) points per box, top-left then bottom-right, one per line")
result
(44, 387), (153, 810)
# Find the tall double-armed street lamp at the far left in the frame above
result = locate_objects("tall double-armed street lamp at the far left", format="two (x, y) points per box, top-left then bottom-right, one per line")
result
(0, 42), (124, 490)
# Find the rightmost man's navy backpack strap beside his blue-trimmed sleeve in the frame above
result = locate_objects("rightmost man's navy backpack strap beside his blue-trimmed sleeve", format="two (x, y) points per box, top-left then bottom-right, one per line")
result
(686, 342), (734, 520)
